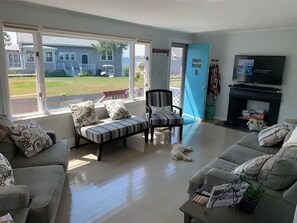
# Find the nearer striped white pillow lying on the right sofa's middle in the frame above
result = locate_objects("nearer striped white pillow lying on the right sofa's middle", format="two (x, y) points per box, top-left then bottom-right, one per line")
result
(232, 155), (274, 179)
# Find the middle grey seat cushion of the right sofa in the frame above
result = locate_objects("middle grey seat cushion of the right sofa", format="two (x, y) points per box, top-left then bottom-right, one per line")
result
(219, 145), (266, 165)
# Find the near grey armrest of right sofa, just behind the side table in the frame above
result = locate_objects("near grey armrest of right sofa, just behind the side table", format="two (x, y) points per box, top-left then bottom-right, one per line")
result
(202, 168), (239, 191)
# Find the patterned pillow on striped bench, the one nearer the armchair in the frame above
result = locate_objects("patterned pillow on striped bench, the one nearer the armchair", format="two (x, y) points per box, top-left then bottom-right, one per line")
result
(104, 100), (131, 120)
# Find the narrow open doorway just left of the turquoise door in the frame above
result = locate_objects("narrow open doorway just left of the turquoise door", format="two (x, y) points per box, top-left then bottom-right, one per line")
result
(169, 43), (187, 107)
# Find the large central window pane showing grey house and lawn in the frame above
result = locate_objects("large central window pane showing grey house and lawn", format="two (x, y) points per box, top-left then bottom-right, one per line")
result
(42, 35), (129, 109)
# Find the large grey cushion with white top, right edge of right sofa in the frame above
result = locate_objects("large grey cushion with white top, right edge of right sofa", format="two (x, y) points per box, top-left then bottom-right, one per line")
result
(257, 126), (297, 190)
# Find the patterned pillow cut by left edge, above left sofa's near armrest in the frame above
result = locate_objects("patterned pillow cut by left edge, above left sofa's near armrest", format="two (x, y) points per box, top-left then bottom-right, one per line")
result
(0, 153), (15, 186)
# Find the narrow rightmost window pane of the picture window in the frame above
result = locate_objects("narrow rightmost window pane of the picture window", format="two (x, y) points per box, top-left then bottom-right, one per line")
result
(134, 44), (147, 98)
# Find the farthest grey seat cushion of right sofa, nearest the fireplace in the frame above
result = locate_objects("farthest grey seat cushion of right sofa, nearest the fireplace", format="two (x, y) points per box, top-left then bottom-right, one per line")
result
(236, 132), (282, 154)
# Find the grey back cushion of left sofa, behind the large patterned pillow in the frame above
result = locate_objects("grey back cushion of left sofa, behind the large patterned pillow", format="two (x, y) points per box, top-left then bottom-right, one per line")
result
(0, 115), (18, 161)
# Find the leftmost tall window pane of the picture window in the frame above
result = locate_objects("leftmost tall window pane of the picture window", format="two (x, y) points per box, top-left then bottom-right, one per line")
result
(4, 31), (38, 116)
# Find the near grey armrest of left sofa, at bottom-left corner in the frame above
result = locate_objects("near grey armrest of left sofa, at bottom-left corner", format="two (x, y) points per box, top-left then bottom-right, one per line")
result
(0, 185), (29, 211)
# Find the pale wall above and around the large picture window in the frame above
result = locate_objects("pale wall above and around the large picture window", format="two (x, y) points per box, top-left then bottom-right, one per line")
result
(0, 1), (191, 145)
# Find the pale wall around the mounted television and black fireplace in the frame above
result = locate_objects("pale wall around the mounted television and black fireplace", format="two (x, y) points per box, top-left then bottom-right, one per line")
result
(194, 29), (297, 122)
